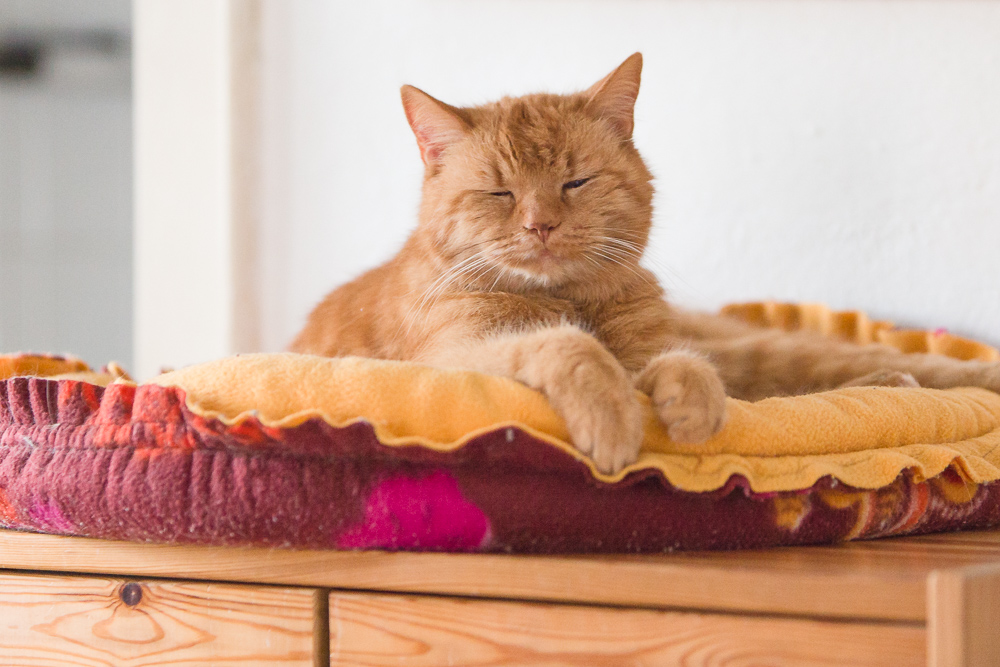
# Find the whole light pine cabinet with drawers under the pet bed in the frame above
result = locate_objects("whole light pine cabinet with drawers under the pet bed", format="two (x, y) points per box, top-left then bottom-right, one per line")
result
(0, 530), (1000, 667)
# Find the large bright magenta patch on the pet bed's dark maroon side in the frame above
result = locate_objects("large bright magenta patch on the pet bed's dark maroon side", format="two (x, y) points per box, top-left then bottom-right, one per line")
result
(337, 470), (492, 551)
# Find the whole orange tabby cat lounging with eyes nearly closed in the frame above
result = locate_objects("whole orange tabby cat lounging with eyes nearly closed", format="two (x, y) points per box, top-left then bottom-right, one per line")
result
(291, 53), (1000, 472)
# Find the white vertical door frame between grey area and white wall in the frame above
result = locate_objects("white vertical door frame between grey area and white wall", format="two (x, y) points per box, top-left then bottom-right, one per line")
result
(134, 0), (260, 378)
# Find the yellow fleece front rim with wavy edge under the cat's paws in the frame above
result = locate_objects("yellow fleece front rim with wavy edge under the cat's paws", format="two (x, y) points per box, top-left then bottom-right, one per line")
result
(146, 354), (1000, 492)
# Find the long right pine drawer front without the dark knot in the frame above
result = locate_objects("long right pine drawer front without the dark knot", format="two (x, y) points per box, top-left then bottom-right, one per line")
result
(330, 593), (925, 667)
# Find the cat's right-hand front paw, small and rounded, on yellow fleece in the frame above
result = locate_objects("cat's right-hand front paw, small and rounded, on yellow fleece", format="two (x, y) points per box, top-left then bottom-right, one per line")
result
(636, 352), (726, 443)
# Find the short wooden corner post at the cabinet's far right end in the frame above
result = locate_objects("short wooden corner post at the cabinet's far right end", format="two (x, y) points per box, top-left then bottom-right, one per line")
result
(927, 565), (1000, 667)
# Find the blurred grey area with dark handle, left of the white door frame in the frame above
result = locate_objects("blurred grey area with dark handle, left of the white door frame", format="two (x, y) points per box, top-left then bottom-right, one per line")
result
(0, 0), (132, 365)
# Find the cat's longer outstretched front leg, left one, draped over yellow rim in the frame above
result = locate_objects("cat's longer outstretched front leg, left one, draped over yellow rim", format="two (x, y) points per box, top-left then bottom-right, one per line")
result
(422, 325), (643, 473)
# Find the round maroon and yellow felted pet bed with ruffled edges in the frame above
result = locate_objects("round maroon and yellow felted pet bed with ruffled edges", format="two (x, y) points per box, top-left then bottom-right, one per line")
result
(0, 304), (1000, 553)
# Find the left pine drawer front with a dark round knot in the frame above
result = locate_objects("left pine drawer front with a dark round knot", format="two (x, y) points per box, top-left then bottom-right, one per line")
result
(0, 573), (315, 667)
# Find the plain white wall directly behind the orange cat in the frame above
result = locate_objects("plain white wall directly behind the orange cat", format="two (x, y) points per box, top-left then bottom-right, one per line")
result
(260, 0), (1000, 349)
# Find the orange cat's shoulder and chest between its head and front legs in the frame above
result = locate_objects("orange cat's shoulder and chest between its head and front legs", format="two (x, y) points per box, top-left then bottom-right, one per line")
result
(293, 240), (675, 373)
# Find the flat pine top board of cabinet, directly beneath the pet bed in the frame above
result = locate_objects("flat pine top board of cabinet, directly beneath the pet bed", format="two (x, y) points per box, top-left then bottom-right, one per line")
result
(0, 531), (1000, 622)
